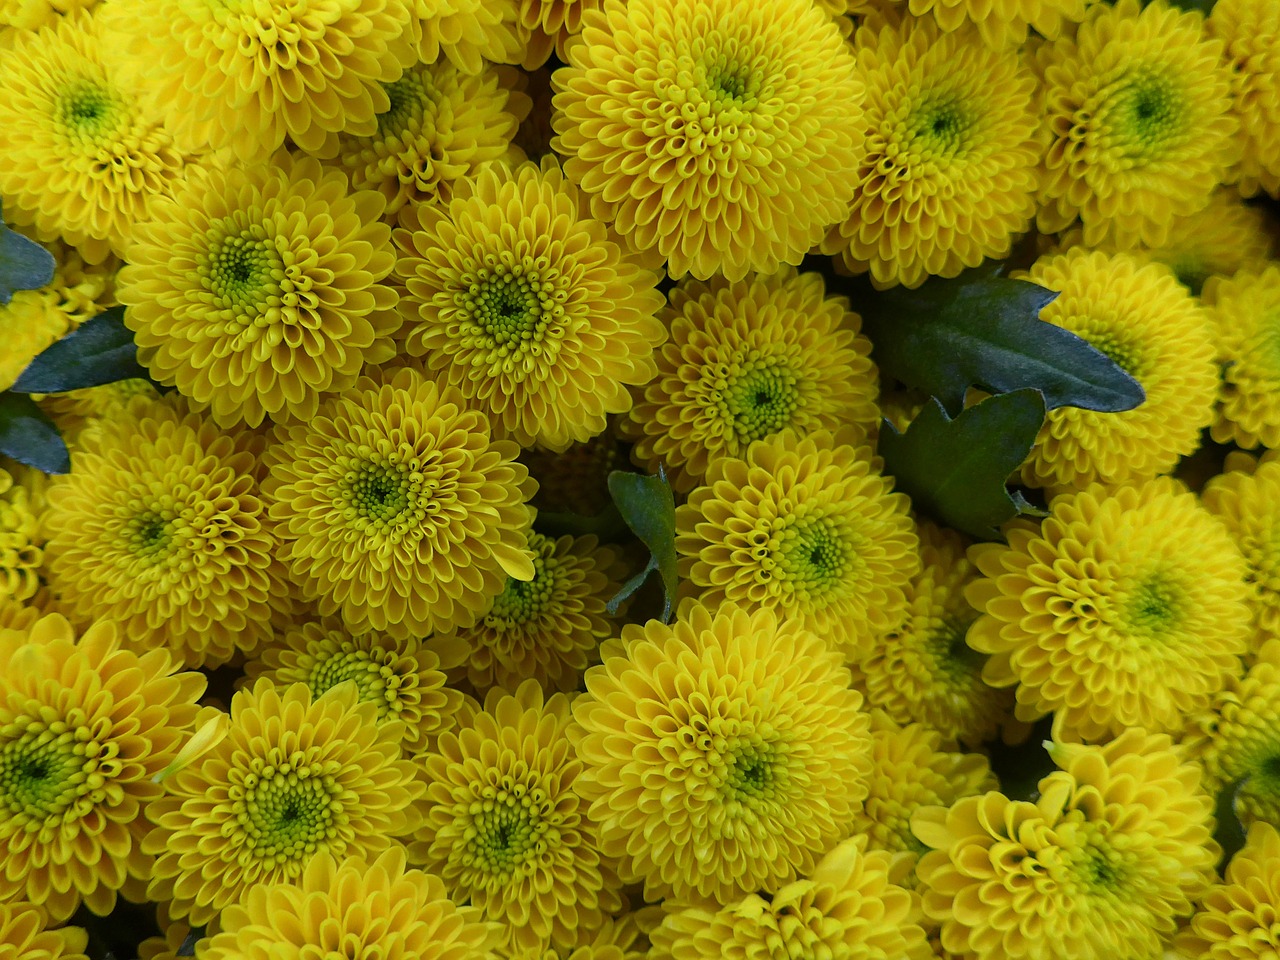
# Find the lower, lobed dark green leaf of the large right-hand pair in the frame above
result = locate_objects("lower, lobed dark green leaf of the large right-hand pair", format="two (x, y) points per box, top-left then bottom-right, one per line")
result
(879, 389), (1044, 540)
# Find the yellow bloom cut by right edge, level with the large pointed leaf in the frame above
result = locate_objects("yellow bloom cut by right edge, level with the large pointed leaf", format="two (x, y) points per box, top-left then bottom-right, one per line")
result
(1203, 264), (1280, 447)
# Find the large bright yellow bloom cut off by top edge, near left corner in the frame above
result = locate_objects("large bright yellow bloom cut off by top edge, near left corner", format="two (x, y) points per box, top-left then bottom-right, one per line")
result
(104, 0), (415, 163)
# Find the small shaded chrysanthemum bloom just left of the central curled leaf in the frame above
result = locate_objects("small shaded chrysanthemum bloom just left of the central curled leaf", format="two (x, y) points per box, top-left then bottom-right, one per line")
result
(435, 534), (626, 692)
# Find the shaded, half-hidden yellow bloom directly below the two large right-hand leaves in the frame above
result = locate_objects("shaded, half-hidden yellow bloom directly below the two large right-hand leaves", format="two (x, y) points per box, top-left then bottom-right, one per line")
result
(851, 521), (1014, 748)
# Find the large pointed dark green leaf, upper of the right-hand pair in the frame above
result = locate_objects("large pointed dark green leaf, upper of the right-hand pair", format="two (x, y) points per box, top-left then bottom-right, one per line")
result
(854, 269), (1146, 413)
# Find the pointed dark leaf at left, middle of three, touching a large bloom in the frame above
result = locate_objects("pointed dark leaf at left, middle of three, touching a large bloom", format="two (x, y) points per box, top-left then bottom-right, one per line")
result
(13, 307), (148, 393)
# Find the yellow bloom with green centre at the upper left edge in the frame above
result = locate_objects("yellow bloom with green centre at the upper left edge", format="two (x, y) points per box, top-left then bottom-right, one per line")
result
(0, 13), (187, 264)
